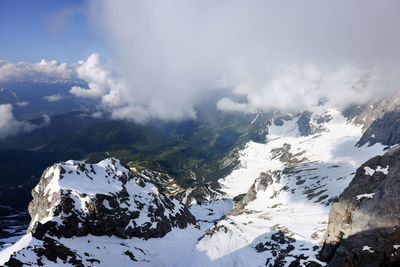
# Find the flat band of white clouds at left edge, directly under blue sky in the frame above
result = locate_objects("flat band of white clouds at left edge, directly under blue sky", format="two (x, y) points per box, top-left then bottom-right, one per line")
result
(0, 59), (76, 82)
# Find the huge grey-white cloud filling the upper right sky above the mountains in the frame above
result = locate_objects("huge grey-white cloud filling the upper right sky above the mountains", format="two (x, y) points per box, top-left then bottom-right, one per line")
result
(81, 0), (400, 121)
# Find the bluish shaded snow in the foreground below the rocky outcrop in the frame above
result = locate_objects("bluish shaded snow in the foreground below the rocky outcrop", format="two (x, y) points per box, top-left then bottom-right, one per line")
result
(0, 199), (233, 267)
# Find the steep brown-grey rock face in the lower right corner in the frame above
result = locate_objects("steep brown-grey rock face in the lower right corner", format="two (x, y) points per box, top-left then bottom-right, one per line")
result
(320, 147), (400, 266)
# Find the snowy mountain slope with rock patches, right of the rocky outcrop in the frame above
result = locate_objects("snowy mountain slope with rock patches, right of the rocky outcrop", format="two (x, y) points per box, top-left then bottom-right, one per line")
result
(198, 110), (384, 266)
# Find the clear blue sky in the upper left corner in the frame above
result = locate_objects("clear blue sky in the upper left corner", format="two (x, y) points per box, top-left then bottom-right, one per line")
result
(0, 0), (106, 63)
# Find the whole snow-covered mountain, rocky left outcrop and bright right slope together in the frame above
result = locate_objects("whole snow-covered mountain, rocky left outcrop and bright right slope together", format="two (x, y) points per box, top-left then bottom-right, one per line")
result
(0, 99), (398, 266)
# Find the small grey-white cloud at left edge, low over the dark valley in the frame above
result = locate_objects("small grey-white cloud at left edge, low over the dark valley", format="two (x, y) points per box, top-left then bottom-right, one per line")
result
(0, 104), (50, 139)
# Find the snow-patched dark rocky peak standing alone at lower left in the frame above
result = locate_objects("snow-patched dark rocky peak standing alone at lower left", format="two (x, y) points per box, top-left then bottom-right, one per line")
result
(28, 158), (195, 241)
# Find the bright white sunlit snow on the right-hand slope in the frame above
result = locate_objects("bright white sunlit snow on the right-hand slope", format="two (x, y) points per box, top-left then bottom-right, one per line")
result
(209, 110), (384, 265)
